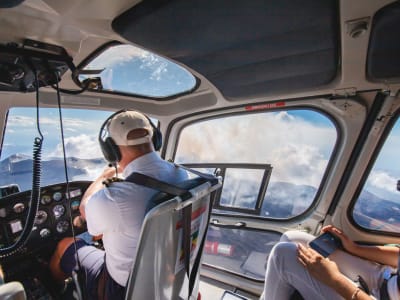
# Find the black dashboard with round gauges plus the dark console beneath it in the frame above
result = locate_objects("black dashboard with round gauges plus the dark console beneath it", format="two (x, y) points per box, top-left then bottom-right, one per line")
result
(0, 181), (92, 300)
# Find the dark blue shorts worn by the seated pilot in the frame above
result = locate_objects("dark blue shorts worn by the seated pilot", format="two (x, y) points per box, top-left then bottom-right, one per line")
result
(60, 239), (125, 300)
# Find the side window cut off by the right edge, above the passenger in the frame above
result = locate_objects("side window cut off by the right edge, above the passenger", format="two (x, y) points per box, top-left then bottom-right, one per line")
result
(352, 118), (400, 233)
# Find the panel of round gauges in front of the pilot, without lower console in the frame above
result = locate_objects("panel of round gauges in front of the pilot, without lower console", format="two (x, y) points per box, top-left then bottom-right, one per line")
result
(0, 181), (92, 251)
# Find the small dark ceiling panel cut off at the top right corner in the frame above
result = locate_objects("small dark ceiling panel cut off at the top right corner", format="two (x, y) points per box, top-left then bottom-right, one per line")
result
(366, 1), (400, 82)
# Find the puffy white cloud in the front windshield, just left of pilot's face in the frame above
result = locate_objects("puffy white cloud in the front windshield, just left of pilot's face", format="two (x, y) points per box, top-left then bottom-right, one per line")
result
(49, 134), (103, 159)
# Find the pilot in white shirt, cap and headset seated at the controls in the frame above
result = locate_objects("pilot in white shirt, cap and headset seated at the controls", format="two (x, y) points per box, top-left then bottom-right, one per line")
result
(50, 111), (188, 299)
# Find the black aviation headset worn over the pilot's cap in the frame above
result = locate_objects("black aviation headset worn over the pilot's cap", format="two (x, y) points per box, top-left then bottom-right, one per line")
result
(99, 109), (162, 165)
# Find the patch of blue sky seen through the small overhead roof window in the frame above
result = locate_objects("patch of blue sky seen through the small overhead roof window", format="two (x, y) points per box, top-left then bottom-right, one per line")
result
(82, 45), (196, 98)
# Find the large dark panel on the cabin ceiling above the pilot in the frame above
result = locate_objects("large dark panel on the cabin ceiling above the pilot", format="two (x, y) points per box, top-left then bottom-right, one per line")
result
(112, 0), (340, 100)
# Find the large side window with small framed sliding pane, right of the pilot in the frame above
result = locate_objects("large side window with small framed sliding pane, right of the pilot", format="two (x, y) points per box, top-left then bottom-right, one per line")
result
(175, 109), (337, 219)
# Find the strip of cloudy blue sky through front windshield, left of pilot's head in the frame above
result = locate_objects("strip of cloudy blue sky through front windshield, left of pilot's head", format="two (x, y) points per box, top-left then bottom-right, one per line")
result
(1, 108), (112, 159)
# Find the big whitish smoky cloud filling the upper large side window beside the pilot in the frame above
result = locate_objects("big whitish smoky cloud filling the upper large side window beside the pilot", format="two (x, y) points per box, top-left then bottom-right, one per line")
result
(176, 112), (337, 187)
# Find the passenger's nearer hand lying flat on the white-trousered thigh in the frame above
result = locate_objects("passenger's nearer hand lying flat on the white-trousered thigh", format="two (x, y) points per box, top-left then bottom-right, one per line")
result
(297, 244), (343, 287)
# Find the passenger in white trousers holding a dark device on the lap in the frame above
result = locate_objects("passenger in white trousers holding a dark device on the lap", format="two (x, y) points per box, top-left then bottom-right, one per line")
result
(261, 226), (400, 300)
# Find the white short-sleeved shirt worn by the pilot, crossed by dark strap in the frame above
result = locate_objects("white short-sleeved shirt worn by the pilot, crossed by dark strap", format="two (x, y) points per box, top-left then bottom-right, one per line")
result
(85, 152), (188, 286)
